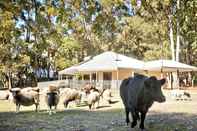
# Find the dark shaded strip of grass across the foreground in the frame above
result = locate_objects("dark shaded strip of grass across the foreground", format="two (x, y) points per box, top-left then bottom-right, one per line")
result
(0, 109), (197, 131)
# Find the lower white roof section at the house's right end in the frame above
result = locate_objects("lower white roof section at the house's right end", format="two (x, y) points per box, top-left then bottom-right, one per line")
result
(144, 60), (197, 72)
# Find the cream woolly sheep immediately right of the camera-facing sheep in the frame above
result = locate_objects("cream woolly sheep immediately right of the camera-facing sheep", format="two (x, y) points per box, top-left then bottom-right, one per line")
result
(61, 88), (81, 108)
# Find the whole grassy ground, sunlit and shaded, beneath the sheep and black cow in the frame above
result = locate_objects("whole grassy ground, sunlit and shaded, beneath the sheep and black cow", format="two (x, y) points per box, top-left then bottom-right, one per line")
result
(0, 89), (197, 131)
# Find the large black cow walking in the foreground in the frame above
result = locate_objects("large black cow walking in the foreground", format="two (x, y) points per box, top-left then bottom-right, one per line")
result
(120, 75), (165, 130)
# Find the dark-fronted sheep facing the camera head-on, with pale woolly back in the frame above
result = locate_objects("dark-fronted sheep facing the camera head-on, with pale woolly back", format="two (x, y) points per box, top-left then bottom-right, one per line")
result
(45, 85), (60, 115)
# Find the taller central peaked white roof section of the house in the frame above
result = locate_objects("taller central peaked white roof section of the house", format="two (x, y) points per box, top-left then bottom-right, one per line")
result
(78, 51), (144, 72)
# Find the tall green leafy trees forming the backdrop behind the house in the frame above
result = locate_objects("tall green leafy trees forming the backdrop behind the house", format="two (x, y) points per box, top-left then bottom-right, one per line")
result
(0, 0), (197, 87)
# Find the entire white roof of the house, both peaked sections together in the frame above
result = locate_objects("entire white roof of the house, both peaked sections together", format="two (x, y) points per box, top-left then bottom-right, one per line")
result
(59, 51), (197, 75)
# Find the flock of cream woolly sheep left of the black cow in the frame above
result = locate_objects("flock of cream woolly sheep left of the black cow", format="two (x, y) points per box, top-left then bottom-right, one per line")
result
(0, 83), (112, 114)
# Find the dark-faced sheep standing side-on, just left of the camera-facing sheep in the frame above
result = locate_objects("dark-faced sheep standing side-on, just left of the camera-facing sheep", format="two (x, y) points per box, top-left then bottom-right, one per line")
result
(10, 87), (40, 112)
